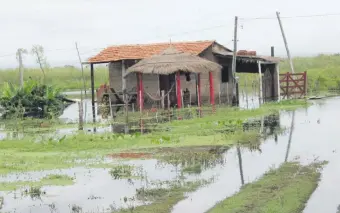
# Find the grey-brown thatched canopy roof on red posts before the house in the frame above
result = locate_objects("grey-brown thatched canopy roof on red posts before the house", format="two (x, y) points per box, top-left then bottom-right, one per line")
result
(127, 46), (222, 75)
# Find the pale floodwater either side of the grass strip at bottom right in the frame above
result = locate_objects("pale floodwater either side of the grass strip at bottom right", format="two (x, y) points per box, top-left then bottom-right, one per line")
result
(172, 98), (340, 213)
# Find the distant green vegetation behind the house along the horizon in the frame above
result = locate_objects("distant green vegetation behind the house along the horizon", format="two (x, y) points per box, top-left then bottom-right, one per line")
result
(0, 55), (340, 91)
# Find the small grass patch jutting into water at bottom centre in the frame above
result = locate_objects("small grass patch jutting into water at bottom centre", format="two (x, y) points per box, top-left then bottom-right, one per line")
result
(114, 181), (204, 213)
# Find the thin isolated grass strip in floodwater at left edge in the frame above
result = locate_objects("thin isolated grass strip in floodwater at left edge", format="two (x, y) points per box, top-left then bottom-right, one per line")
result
(0, 175), (74, 191)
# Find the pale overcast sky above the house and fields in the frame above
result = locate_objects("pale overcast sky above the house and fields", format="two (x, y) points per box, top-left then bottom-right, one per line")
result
(0, 0), (340, 68)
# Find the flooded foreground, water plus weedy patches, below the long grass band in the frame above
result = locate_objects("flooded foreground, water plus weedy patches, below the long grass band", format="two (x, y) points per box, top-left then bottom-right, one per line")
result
(0, 98), (340, 213)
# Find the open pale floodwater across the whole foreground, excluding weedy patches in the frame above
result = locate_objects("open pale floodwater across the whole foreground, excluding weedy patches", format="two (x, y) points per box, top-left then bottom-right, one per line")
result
(0, 97), (340, 213)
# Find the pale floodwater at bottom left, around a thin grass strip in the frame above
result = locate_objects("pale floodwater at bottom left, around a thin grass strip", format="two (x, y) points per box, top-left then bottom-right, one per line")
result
(0, 160), (193, 213)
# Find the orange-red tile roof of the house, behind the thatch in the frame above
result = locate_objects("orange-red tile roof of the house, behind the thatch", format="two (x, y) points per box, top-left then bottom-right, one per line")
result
(88, 41), (215, 63)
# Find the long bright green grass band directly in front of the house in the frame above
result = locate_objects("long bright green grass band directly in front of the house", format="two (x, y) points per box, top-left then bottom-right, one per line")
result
(0, 101), (306, 174)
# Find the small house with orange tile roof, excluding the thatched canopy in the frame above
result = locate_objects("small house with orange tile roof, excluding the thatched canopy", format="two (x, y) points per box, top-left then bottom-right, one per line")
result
(87, 41), (279, 110)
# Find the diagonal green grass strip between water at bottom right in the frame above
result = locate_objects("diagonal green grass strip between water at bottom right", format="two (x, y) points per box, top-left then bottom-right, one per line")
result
(208, 162), (325, 213)
